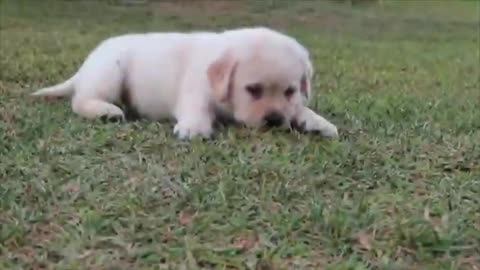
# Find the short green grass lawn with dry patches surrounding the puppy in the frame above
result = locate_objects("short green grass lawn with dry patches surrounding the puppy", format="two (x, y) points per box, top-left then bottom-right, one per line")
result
(0, 0), (480, 269)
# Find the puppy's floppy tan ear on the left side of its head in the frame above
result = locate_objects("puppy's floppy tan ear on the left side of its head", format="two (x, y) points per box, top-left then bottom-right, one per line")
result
(207, 50), (237, 102)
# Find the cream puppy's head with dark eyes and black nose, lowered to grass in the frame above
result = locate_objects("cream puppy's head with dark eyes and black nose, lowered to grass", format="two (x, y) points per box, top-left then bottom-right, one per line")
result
(208, 31), (313, 127)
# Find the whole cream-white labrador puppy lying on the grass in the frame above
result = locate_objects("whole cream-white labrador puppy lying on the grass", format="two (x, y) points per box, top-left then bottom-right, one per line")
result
(33, 27), (338, 139)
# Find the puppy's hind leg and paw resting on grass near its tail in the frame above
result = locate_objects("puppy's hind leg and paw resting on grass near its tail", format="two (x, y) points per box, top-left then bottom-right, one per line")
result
(72, 97), (125, 121)
